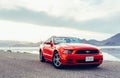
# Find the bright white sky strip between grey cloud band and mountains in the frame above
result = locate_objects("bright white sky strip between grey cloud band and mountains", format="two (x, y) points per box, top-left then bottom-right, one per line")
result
(0, 20), (110, 42)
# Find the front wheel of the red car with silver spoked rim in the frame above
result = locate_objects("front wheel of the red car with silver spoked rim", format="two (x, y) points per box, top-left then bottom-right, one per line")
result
(52, 52), (63, 69)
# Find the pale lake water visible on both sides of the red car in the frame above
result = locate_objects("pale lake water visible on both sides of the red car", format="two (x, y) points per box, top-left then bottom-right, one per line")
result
(0, 46), (120, 61)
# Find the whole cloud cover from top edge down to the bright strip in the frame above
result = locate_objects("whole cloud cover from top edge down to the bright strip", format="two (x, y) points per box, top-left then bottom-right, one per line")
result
(0, 0), (120, 34)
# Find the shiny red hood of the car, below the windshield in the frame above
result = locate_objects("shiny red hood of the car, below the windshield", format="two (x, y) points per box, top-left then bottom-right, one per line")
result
(59, 43), (98, 49)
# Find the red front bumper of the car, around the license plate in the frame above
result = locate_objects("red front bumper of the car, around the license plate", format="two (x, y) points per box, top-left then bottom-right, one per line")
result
(60, 54), (103, 65)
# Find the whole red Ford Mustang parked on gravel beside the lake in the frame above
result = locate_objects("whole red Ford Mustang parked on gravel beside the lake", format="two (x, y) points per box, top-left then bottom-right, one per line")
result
(39, 36), (103, 68)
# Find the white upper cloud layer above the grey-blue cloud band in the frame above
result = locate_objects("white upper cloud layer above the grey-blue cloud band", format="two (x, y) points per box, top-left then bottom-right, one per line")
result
(0, 0), (120, 21)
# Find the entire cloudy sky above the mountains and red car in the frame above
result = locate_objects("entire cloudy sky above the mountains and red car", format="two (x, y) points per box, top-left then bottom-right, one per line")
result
(0, 0), (120, 42)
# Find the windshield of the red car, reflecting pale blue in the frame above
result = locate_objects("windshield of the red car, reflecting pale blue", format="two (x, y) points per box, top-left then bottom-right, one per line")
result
(54, 37), (81, 44)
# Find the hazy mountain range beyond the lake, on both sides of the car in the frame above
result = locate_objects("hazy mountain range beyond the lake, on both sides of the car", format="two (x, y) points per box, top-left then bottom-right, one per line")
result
(0, 33), (120, 47)
